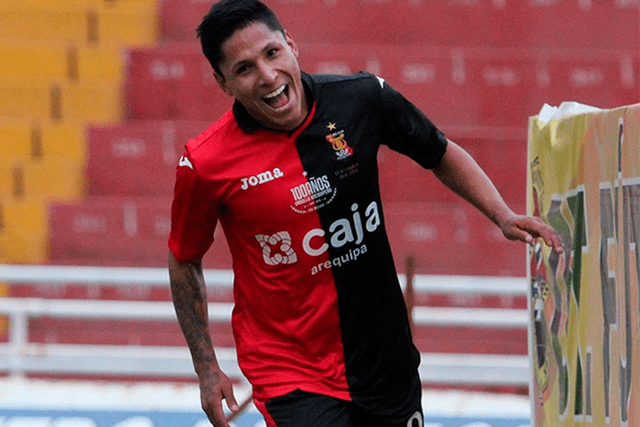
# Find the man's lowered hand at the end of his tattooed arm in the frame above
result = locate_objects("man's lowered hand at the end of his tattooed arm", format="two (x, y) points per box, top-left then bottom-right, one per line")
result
(200, 371), (239, 427)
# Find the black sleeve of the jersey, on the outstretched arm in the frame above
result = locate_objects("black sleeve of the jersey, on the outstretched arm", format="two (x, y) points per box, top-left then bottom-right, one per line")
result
(378, 77), (447, 169)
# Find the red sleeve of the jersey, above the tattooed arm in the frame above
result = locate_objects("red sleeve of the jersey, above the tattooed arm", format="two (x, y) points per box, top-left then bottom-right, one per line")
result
(169, 153), (219, 262)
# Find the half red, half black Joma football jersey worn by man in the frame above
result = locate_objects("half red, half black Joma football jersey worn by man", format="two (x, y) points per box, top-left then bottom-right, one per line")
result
(169, 73), (446, 420)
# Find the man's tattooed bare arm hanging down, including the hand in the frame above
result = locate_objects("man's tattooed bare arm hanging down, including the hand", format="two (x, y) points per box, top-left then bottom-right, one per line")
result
(168, 252), (238, 427)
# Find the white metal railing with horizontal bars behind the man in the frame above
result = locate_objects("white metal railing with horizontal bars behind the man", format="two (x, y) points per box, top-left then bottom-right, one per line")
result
(0, 265), (531, 386)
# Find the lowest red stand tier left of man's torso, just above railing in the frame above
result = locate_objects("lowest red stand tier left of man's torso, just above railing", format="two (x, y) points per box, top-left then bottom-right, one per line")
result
(50, 196), (231, 269)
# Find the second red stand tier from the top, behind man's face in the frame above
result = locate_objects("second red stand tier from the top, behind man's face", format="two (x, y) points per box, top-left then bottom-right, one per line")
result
(127, 43), (638, 127)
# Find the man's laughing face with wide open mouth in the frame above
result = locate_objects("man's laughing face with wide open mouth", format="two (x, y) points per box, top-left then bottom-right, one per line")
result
(215, 21), (308, 131)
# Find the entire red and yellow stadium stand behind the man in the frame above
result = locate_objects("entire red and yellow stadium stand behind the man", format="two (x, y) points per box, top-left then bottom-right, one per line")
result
(0, 0), (640, 398)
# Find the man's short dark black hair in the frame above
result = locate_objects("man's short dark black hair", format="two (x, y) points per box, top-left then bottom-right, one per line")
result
(197, 0), (284, 73)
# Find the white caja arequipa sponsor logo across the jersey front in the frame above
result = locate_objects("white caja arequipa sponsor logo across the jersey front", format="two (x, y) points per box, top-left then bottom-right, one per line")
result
(255, 201), (381, 274)
